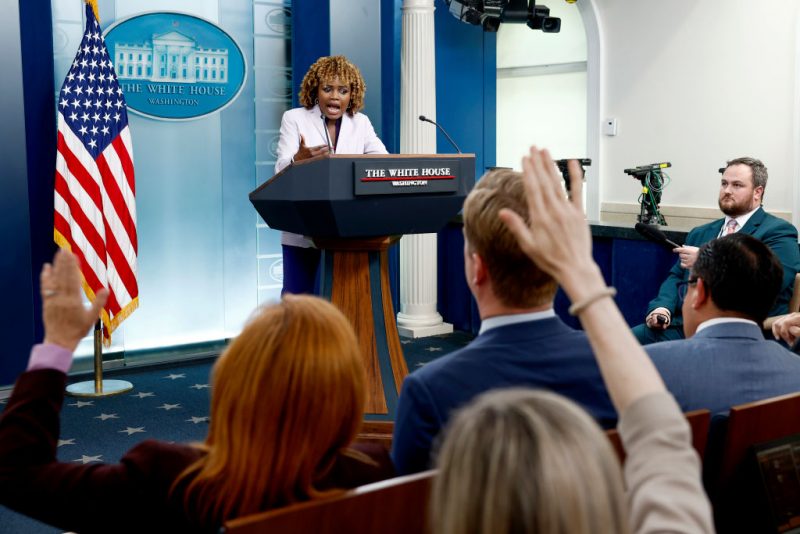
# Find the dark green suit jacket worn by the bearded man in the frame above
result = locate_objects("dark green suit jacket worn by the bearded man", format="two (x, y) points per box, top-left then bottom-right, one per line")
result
(647, 208), (800, 326)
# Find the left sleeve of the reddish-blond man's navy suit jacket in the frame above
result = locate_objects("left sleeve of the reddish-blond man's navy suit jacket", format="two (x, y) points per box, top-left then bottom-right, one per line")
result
(392, 373), (442, 475)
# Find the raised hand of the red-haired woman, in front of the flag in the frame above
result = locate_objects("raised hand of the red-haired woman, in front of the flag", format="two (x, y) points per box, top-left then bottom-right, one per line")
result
(40, 250), (108, 352)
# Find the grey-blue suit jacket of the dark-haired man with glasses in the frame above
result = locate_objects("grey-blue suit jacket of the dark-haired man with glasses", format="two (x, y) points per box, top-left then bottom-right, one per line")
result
(644, 323), (800, 413)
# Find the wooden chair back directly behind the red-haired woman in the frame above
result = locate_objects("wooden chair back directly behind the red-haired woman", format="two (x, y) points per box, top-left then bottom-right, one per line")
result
(223, 471), (436, 534)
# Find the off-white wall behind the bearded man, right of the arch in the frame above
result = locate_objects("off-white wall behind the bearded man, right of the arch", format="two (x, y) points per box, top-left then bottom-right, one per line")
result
(579, 0), (800, 219)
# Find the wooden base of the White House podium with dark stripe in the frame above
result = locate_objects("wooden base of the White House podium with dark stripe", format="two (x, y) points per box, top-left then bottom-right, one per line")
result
(314, 236), (408, 421)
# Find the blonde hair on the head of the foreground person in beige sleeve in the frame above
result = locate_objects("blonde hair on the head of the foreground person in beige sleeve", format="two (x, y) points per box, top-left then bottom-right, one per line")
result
(432, 388), (630, 534)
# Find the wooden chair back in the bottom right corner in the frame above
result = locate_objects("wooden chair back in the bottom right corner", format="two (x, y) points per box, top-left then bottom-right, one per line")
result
(706, 392), (800, 533)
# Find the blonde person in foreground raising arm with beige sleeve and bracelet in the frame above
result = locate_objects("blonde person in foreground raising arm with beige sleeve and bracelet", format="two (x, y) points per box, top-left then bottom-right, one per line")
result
(432, 147), (714, 534)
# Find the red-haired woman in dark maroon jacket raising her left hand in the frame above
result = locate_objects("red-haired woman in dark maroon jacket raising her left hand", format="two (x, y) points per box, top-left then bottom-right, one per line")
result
(0, 251), (393, 533)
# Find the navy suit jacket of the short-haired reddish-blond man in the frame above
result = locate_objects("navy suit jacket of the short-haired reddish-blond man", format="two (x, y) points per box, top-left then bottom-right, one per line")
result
(392, 317), (617, 473)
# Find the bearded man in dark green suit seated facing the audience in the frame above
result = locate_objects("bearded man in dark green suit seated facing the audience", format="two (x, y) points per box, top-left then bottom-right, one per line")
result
(633, 158), (800, 345)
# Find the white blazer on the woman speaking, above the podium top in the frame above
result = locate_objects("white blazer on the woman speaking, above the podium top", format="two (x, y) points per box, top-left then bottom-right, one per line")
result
(275, 105), (387, 173)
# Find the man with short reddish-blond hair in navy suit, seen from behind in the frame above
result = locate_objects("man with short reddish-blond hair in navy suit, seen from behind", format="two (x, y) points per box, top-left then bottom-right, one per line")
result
(392, 169), (616, 473)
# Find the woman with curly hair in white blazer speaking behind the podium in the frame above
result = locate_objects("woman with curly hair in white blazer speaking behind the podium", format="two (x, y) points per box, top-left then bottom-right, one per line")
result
(275, 56), (387, 293)
